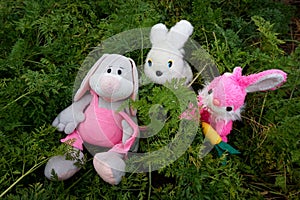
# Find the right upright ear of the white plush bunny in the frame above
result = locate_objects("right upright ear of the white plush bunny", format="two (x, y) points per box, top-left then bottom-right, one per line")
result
(167, 20), (194, 49)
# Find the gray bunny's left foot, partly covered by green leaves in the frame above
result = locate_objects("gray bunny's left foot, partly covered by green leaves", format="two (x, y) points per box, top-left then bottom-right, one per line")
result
(44, 152), (83, 181)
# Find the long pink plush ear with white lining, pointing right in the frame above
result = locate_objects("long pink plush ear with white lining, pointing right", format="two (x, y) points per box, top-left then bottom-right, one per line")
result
(241, 69), (287, 92)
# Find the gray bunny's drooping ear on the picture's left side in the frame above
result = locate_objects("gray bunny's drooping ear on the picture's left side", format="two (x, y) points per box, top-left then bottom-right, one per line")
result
(74, 54), (108, 101)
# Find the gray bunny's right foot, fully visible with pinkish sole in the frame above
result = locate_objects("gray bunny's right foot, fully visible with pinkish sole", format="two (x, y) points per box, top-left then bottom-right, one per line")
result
(93, 152), (125, 185)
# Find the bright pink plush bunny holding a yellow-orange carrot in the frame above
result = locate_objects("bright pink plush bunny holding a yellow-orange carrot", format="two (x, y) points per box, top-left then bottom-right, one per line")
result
(198, 67), (287, 155)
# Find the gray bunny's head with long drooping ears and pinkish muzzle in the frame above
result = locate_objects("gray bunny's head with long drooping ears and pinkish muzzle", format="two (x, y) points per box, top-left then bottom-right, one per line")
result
(74, 54), (138, 102)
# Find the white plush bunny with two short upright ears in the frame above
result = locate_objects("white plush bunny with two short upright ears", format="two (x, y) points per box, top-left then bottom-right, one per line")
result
(144, 20), (193, 84)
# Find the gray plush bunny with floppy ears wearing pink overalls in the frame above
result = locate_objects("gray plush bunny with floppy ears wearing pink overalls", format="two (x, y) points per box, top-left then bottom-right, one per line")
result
(45, 54), (139, 185)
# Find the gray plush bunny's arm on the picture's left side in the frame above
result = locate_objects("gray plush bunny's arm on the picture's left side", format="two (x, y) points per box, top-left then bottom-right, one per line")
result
(52, 94), (92, 134)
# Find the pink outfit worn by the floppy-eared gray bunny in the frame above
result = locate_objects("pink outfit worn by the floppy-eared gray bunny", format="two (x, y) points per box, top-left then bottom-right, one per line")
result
(61, 90), (138, 154)
